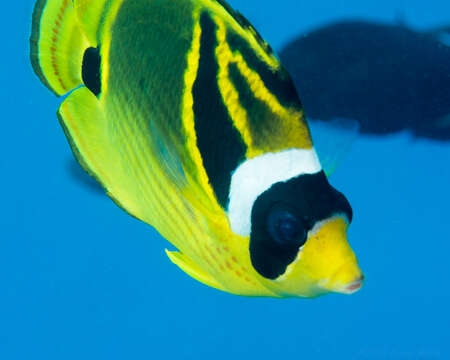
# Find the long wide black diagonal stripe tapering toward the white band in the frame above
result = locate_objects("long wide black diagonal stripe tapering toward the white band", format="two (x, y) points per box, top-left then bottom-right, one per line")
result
(192, 13), (246, 208)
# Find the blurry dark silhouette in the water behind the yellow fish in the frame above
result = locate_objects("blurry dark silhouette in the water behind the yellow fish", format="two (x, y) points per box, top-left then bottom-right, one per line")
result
(280, 21), (450, 140)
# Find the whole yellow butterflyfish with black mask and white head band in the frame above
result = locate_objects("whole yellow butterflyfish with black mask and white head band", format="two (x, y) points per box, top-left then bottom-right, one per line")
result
(31, 0), (363, 297)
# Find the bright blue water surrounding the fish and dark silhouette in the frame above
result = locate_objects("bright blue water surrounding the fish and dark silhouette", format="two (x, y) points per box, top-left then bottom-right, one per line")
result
(0, 0), (450, 360)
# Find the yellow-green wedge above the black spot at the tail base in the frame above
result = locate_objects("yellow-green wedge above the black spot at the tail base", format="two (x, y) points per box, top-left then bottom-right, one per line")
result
(73, 0), (108, 47)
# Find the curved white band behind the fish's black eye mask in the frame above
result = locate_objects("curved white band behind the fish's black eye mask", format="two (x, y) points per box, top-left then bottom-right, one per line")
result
(228, 149), (322, 236)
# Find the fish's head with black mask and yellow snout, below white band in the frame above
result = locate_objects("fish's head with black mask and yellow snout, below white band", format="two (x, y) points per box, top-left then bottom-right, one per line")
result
(249, 173), (364, 297)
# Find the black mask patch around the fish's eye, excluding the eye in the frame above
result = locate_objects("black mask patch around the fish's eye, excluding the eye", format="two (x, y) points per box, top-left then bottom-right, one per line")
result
(249, 171), (353, 279)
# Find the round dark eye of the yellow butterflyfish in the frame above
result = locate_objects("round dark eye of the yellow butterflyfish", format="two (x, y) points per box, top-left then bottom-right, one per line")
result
(267, 206), (307, 247)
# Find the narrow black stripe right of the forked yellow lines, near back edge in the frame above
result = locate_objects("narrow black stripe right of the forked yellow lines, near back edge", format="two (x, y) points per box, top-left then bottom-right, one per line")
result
(227, 31), (302, 109)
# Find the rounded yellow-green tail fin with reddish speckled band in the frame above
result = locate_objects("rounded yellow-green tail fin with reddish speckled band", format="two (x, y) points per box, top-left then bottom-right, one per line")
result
(30, 0), (90, 96)
